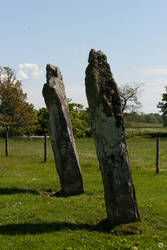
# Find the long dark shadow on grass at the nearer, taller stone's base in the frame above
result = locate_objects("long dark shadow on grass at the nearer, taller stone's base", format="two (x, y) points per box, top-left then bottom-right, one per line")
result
(0, 220), (142, 235)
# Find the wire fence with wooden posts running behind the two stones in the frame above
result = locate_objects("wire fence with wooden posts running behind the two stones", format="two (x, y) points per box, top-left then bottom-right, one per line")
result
(0, 136), (167, 174)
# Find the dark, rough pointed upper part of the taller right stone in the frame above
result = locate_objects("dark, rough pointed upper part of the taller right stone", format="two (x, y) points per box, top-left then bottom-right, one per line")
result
(85, 49), (124, 129)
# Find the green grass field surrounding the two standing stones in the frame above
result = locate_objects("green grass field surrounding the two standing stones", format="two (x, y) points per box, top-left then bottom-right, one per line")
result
(0, 137), (167, 250)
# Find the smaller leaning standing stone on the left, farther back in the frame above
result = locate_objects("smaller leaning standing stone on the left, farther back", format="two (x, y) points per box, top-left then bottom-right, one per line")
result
(43, 64), (83, 196)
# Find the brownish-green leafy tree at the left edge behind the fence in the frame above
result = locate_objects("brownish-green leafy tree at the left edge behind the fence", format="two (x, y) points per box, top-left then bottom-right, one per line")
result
(0, 67), (36, 134)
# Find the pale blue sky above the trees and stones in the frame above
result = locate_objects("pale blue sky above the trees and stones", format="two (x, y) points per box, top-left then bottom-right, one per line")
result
(0, 0), (167, 113)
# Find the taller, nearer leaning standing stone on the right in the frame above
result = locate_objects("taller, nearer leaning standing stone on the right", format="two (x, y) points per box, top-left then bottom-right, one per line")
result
(85, 49), (140, 225)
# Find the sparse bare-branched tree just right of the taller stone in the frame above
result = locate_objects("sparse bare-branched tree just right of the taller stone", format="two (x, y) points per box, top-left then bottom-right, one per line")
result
(119, 83), (141, 112)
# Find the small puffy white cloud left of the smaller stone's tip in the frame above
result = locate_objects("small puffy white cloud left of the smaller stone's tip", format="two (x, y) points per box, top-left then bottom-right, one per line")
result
(17, 63), (43, 80)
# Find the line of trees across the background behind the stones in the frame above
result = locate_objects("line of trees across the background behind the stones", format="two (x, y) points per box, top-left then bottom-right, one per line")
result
(0, 67), (167, 137)
